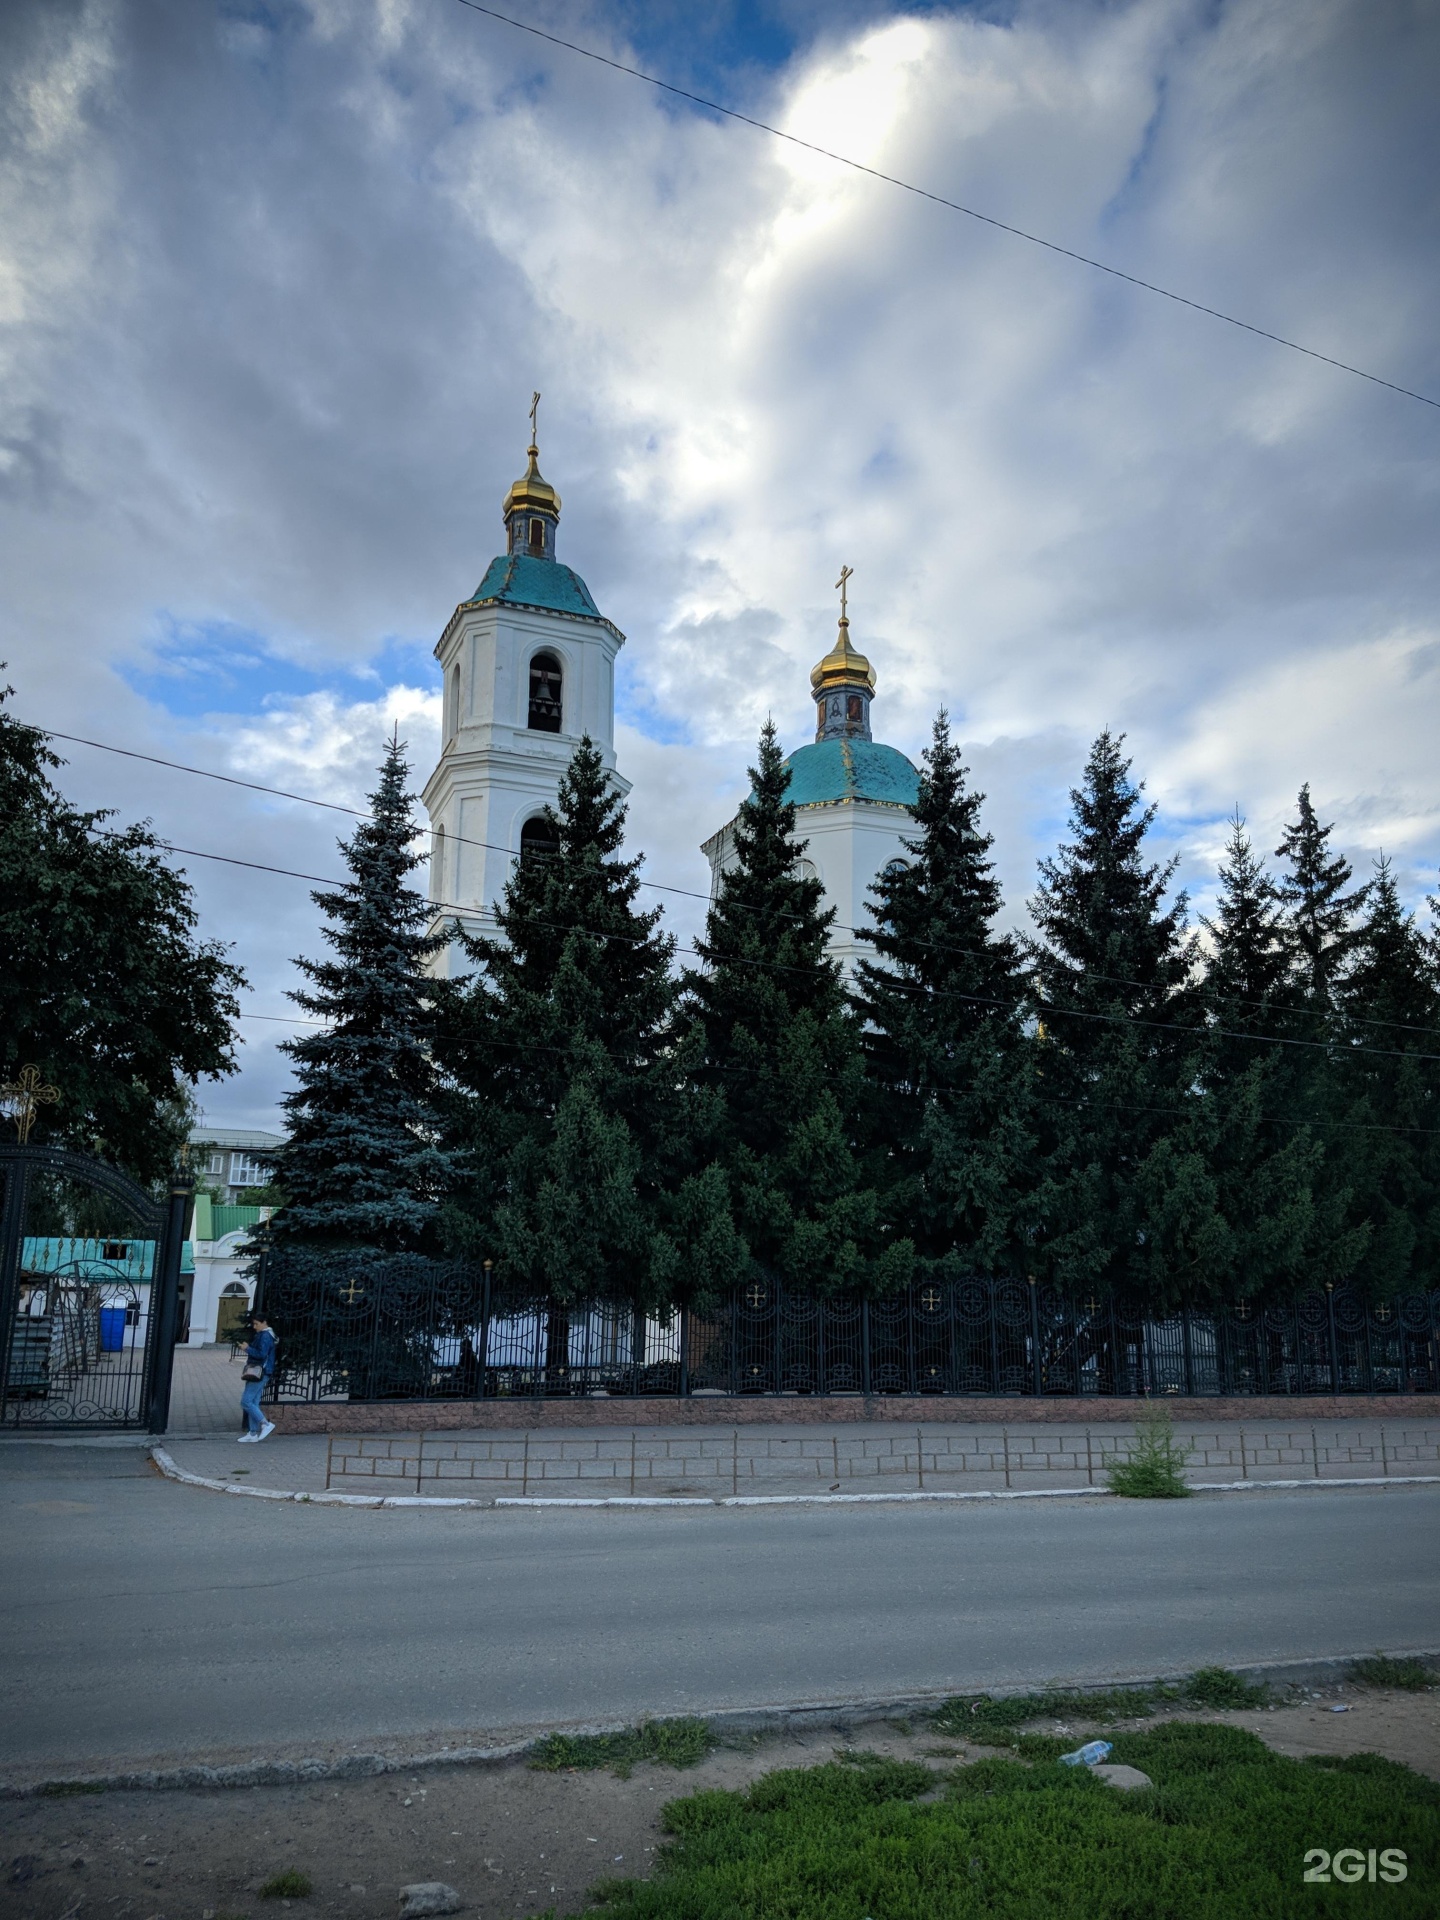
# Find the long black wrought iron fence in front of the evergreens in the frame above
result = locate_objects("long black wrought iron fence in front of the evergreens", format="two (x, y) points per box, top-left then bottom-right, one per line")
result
(263, 1256), (1440, 1402)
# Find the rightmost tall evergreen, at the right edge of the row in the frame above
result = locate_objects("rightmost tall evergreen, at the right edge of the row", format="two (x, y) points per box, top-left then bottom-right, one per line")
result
(1334, 858), (1440, 1298)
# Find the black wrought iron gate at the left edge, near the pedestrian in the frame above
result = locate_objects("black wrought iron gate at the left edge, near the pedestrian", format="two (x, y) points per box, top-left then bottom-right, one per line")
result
(0, 1146), (190, 1432)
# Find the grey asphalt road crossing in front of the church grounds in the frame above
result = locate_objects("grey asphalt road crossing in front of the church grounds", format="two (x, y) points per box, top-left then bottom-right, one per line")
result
(0, 1444), (1440, 1770)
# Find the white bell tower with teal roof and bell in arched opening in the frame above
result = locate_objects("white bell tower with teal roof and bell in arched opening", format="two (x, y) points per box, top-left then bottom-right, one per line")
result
(422, 405), (630, 972)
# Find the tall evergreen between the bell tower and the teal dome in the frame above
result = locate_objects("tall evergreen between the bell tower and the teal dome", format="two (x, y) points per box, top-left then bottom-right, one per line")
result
(685, 722), (912, 1290)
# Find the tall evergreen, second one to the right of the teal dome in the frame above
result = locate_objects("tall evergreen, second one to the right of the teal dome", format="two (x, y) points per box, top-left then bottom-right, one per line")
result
(1031, 732), (1223, 1304)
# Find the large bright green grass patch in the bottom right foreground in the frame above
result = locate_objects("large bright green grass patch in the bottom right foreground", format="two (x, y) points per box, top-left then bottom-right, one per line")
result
(579, 1722), (1440, 1920)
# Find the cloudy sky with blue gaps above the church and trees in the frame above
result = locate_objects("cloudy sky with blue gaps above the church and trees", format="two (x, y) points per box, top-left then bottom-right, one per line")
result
(0, 0), (1440, 1125)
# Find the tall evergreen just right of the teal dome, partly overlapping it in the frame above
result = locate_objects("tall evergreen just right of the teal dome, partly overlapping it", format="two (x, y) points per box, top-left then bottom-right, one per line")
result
(856, 710), (1035, 1271)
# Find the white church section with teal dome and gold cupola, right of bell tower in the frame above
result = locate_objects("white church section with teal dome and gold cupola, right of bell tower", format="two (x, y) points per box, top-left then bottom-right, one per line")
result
(701, 566), (920, 968)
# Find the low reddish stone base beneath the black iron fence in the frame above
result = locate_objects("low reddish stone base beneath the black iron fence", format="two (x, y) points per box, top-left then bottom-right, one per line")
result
(265, 1394), (1440, 1434)
